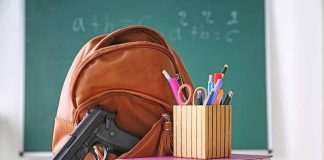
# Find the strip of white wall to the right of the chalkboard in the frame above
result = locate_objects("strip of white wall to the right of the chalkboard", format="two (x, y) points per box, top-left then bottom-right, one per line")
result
(267, 0), (324, 160)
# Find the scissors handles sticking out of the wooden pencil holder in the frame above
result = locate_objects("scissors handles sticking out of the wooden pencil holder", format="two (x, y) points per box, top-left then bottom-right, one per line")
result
(178, 84), (207, 105)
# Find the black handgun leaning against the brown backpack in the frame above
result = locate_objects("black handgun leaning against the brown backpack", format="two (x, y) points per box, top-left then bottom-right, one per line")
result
(53, 105), (140, 160)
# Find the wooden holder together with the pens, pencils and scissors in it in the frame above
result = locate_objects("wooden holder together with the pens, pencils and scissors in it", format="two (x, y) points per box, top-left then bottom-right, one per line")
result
(166, 65), (233, 159)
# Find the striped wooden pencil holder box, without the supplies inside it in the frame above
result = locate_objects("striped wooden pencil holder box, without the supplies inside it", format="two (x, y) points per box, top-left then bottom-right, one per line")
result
(173, 105), (232, 159)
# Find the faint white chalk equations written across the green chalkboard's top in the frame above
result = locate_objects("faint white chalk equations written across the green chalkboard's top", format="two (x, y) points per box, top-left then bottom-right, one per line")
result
(72, 10), (240, 43)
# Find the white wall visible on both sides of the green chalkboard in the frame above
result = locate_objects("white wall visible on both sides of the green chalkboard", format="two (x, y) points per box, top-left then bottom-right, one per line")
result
(0, 0), (324, 160)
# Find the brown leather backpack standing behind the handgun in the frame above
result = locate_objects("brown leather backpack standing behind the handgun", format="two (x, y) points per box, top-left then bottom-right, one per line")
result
(52, 26), (192, 158)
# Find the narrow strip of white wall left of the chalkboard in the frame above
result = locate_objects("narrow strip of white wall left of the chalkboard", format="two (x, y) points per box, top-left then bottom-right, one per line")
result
(0, 0), (24, 160)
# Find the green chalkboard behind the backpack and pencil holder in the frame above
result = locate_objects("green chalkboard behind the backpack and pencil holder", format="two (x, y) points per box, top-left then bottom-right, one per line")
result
(24, 0), (268, 152)
